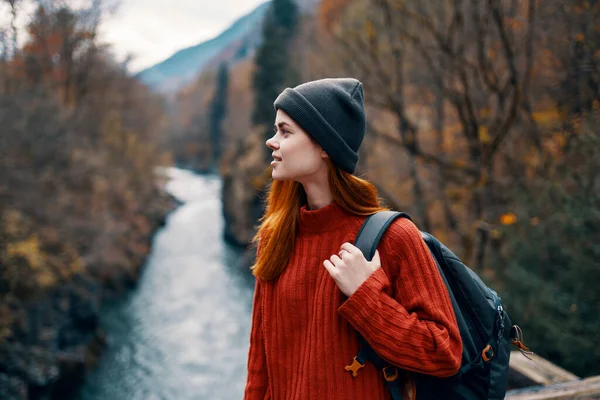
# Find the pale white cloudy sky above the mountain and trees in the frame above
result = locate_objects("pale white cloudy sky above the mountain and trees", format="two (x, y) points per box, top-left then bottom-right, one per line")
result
(0, 0), (266, 72)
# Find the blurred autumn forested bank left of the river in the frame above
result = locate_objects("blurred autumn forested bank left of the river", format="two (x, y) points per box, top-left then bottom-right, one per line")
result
(0, 1), (171, 399)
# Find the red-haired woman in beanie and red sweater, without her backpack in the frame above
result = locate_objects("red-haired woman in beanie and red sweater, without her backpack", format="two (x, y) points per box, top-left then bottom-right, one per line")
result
(245, 78), (462, 400)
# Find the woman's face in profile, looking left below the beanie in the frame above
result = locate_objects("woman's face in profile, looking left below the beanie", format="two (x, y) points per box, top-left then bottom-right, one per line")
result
(266, 110), (328, 183)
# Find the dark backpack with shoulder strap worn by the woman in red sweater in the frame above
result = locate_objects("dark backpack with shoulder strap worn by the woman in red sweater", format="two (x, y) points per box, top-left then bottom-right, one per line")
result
(346, 211), (531, 400)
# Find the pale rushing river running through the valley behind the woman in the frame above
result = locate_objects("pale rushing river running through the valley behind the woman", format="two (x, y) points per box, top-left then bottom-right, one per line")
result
(77, 168), (254, 400)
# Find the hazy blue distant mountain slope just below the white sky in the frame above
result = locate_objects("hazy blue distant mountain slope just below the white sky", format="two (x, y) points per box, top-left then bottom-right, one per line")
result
(136, 1), (270, 94)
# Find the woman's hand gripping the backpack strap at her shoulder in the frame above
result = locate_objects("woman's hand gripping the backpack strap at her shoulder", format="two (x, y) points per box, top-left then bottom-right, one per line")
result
(323, 242), (381, 297)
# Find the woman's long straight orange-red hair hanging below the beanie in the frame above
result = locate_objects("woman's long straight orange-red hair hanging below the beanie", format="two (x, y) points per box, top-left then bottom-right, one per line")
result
(250, 158), (388, 280)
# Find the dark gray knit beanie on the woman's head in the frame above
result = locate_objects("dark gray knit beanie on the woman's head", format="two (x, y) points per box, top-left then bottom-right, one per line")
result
(273, 78), (366, 174)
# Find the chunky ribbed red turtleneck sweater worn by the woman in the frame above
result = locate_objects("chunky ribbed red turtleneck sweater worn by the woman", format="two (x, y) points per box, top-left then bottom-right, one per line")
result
(244, 203), (462, 400)
